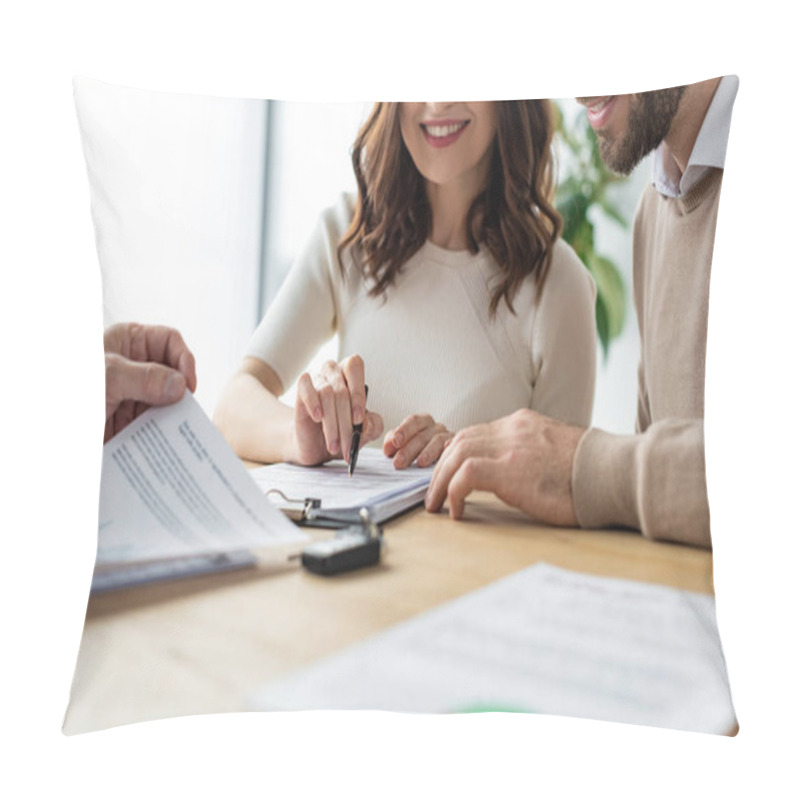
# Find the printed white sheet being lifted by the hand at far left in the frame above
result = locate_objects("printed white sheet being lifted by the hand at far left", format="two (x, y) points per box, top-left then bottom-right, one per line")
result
(97, 392), (308, 568)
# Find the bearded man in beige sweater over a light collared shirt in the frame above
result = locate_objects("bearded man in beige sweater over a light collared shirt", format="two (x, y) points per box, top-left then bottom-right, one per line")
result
(425, 76), (738, 547)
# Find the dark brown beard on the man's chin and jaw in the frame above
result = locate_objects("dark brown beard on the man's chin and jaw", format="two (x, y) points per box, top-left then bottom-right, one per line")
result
(597, 86), (686, 175)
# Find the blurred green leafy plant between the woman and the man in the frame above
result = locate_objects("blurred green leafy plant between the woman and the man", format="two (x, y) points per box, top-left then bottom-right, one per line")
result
(555, 105), (628, 358)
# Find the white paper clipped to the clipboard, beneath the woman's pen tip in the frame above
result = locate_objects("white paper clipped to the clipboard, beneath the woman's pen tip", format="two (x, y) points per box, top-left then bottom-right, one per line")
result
(251, 448), (433, 522)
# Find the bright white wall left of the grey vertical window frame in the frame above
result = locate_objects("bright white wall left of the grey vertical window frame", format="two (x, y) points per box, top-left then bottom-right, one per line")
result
(75, 79), (267, 413)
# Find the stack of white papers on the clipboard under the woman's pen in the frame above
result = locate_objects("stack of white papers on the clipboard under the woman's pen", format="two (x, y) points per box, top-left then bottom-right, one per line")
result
(250, 448), (433, 524)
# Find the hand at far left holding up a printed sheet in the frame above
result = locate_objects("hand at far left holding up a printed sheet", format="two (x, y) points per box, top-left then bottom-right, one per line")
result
(103, 322), (197, 442)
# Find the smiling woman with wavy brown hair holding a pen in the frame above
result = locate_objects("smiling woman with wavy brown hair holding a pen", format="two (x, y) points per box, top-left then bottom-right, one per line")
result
(216, 101), (595, 476)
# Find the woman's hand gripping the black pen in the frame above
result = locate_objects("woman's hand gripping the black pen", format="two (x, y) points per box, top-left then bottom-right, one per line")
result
(284, 356), (383, 466)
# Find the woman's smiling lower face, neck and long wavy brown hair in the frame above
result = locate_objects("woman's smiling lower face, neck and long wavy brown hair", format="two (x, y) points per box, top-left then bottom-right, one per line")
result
(339, 100), (561, 314)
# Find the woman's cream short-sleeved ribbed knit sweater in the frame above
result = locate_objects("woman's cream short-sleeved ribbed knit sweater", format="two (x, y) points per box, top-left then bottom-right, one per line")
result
(247, 195), (596, 432)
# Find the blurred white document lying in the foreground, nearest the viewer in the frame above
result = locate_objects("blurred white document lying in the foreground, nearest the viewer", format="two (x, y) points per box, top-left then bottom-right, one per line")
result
(250, 564), (735, 734)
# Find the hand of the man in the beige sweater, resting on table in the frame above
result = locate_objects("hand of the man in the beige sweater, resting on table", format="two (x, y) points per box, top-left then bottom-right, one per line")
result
(425, 410), (585, 527)
